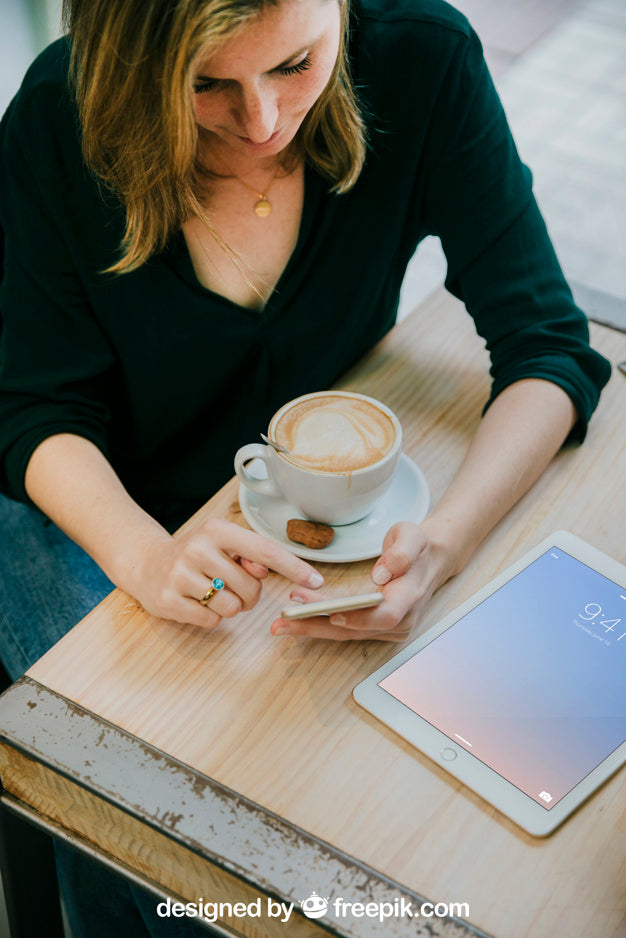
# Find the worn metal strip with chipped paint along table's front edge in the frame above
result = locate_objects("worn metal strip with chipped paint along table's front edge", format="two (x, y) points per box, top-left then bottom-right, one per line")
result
(0, 676), (489, 938)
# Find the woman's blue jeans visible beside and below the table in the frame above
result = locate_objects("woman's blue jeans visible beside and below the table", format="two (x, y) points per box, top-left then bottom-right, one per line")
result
(0, 495), (210, 938)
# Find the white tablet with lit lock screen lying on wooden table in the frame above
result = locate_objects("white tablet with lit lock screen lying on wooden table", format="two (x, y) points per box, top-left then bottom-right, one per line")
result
(353, 531), (626, 837)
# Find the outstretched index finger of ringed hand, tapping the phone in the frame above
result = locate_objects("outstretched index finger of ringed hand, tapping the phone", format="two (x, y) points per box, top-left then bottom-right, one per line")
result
(205, 518), (324, 589)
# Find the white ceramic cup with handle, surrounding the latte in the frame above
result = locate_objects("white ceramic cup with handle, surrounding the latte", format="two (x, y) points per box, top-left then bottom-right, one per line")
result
(235, 391), (402, 525)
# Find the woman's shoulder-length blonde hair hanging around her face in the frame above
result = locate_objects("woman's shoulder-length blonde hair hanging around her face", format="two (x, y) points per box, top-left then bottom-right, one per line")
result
(64, 0), (365, 273)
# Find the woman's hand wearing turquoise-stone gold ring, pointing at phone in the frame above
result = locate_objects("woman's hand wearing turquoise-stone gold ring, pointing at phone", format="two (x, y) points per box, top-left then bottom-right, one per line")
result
(125, 518), (324, 629)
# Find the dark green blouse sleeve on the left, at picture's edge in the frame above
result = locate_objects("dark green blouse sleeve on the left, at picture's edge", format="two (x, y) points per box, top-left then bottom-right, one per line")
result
(0, 49), (113, 499)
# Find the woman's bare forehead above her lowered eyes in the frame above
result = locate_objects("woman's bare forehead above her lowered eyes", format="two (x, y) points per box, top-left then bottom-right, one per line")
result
(195, 0), (338, 79)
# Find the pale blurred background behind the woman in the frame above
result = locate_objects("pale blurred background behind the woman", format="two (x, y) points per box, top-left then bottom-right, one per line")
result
(0, 0), (626, 938)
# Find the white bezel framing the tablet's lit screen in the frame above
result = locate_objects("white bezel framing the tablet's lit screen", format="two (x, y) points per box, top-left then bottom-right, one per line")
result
(352, 531), (626, 837)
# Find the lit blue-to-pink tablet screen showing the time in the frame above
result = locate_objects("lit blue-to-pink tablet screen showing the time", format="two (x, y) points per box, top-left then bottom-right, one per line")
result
(379, 547), (626, 811)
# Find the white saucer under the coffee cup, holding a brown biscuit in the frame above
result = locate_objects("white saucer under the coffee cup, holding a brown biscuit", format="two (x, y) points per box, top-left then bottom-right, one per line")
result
(239, 453), (430, 563)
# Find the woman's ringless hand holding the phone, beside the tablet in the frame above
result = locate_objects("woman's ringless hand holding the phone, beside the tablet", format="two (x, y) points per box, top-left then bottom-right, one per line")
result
(271, 521), (452, 642)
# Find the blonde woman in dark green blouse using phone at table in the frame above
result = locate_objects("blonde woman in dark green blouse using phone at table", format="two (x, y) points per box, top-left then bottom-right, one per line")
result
(0, 0), (609, 933)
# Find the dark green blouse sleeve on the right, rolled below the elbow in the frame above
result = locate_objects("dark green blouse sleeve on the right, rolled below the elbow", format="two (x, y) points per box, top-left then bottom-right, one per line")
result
(416, 23), (610, 439)
